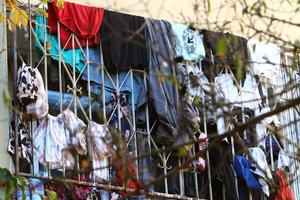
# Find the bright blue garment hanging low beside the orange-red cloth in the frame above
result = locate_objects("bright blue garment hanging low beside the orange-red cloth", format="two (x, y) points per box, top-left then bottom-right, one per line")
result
(233, 156), (261, 190)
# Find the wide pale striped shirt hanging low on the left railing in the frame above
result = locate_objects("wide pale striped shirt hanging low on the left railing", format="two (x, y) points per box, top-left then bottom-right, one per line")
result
(33, 109), (87, 169)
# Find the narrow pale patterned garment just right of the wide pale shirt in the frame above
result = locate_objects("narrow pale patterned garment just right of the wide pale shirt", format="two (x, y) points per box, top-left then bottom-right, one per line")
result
(86, 121), (111, 181)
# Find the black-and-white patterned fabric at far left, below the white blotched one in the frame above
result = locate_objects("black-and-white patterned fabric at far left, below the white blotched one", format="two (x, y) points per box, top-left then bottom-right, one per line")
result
(7, 115), (32, 163)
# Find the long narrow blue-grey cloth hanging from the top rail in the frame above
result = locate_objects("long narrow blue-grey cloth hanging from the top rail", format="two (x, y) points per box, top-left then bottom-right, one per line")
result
(146, 19), (179, 145)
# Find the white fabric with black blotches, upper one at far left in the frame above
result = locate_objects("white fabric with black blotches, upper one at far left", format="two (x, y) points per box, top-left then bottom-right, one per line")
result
(17, 63), (48, 119)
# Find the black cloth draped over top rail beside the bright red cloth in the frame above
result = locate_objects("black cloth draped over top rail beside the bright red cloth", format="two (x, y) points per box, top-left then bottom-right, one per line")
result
(99, 10), (148, 73)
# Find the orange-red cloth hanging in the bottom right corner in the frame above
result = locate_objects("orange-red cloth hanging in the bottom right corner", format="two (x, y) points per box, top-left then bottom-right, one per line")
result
(274, 169), (295, 200)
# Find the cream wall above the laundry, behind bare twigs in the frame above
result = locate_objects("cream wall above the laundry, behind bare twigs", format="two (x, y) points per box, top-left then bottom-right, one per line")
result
(27, 0), (300, 41)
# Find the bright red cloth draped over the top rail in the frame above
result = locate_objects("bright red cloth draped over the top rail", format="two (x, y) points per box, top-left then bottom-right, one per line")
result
(48, 0), (104, 49)
